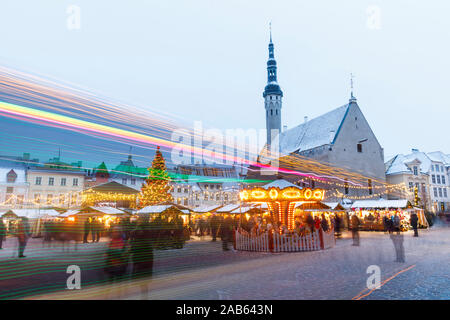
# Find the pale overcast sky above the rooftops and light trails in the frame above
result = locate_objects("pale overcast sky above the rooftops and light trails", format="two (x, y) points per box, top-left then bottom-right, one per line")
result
(0, 0), (450, 160)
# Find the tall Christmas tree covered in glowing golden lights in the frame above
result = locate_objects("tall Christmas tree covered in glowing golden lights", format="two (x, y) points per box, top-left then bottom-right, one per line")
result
(139, 146), (173, 208)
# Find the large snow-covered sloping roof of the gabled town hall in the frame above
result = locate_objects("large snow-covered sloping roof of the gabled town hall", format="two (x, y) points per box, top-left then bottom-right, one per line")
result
(280, 104), (349, 154)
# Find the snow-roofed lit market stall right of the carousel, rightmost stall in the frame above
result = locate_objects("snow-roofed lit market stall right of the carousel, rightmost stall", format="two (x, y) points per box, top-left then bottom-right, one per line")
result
(350, 199), (428, 231)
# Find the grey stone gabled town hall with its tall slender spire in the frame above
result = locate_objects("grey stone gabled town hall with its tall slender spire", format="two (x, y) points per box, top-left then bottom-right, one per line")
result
(248, 29), (386, 201)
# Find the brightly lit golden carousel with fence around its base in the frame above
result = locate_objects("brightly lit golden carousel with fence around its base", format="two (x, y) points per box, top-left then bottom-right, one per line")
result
(235, 179), (335, 252)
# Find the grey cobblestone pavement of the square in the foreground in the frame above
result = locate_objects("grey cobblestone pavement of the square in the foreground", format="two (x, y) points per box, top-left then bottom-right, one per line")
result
(27, 228), (450, 300)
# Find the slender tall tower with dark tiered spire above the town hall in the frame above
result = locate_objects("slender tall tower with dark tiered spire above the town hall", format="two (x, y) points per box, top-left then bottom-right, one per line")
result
(263, 30), (283, 146)
